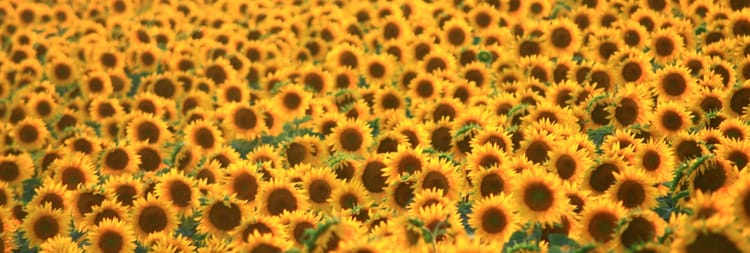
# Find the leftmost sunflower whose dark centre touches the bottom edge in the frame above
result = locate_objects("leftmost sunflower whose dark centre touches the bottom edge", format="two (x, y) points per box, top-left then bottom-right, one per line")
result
(87, 219), (136, 252)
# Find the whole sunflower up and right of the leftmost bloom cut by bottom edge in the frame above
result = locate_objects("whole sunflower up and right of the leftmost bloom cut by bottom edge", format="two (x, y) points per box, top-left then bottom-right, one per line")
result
(130, 195), (177, 242)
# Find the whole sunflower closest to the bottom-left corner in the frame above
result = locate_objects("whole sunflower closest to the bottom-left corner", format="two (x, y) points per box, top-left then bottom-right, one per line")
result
(22, 204), (69, 246)
